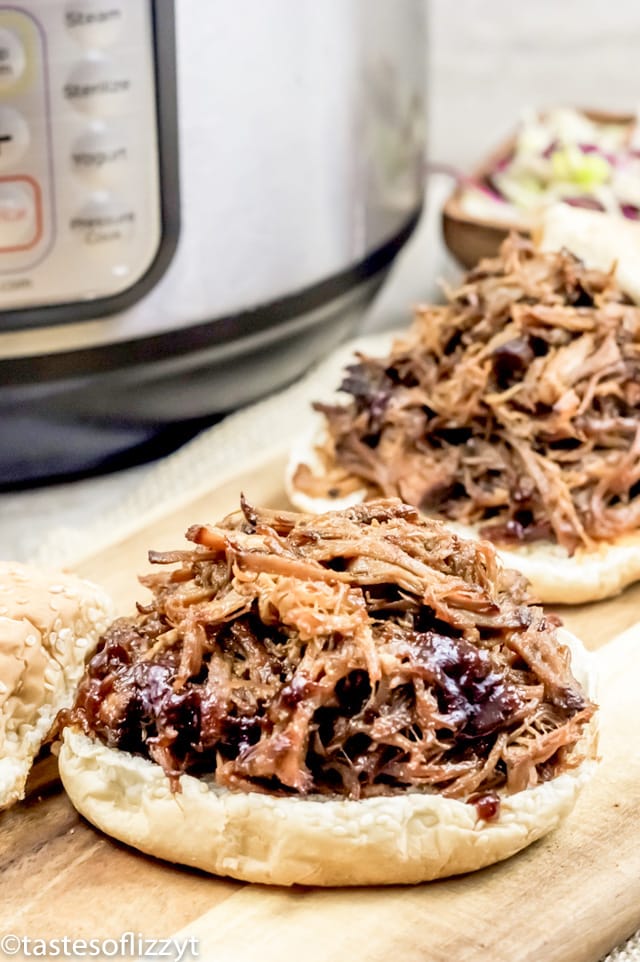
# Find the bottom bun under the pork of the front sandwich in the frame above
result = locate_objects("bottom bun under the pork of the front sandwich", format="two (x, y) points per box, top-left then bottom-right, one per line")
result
(59, 630), (597, 886)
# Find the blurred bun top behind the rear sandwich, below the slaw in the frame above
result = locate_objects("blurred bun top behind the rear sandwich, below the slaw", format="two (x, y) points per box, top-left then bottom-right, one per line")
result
(534, 204), (640, 304)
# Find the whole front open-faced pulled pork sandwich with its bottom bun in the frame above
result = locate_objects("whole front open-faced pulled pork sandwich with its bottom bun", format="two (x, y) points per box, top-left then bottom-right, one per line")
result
(58, 500), (595, 885)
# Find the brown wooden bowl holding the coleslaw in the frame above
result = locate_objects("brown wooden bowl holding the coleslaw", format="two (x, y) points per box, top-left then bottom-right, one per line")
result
(442, 110), (636, 268)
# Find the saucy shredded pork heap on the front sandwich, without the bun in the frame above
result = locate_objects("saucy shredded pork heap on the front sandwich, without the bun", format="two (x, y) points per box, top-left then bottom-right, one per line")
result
(59, 500), (594, 817)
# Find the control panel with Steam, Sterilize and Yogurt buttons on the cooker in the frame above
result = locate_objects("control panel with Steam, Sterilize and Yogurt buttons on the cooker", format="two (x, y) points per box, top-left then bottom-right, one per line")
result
(0, 0), (161, 314)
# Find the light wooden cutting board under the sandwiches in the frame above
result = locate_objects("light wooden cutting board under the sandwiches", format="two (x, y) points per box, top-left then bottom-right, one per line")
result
(0, 454), (640, 962)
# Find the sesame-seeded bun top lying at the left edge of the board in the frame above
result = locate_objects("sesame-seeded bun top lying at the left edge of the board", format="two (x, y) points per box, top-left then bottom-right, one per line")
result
(0, 562), (112, 809)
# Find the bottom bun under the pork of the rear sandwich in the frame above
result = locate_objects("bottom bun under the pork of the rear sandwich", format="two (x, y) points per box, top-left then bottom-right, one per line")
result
(284, 411), (640, 605)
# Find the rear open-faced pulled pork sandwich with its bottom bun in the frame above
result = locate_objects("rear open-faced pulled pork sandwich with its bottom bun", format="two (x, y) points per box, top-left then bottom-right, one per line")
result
(287, 235), (640, 603)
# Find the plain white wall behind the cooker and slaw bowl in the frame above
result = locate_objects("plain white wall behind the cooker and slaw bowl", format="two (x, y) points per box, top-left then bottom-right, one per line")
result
(427, 0), (640, 168)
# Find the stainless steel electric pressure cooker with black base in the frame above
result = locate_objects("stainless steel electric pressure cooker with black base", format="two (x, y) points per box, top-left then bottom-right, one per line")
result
(0, 0), (425, 485)
